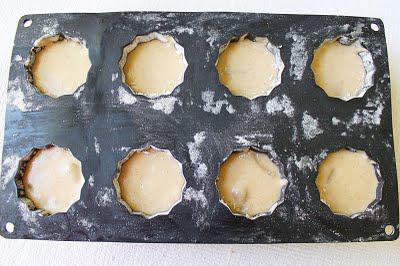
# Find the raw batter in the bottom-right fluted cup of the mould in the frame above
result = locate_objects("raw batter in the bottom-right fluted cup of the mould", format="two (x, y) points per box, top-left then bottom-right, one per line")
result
(316, 149), (378, 216)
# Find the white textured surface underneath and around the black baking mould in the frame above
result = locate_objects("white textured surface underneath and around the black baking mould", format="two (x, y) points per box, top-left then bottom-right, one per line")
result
(0, 0), (400, 265)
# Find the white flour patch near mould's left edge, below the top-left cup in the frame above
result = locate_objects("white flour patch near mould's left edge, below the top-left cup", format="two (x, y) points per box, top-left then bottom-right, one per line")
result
(7, 77), (40, 112)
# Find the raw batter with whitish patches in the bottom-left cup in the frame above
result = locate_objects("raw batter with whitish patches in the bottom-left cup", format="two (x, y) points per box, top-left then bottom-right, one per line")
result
(22, 147), (85, 214)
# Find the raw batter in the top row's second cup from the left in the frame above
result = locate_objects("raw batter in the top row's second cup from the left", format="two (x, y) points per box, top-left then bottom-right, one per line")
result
(122, 33), (187, 98)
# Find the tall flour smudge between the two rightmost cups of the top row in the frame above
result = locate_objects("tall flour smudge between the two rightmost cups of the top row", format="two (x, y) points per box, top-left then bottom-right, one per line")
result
(285, 31), (308, 80)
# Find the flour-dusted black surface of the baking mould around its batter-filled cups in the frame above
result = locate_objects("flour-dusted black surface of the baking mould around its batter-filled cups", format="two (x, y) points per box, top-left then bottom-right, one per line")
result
(0, 12), (399, 243)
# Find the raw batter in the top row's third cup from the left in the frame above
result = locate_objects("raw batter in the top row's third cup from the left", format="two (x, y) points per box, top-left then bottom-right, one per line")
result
(216, 36), (284, 100)
